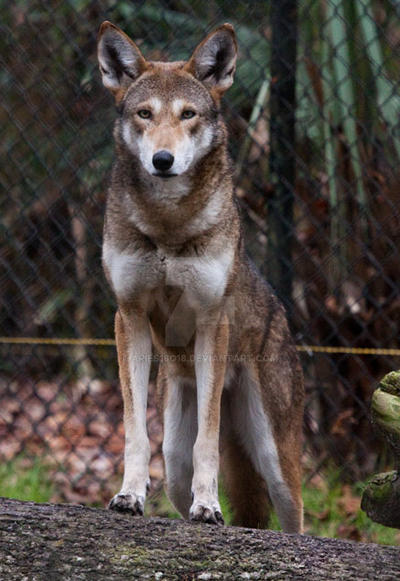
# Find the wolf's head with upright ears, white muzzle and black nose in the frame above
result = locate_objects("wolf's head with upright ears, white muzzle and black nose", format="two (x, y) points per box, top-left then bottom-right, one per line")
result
(98, 22), (237, 179)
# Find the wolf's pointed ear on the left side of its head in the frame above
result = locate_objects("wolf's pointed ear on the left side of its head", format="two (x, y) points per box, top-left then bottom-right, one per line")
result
(97, 21), (146, 98)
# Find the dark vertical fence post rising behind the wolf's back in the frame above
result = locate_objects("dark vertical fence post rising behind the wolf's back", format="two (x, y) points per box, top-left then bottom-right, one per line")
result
(267, 0), (297, 316)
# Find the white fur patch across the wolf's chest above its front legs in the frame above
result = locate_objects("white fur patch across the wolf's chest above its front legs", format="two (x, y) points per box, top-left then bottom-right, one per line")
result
(103, 243), (234, 309)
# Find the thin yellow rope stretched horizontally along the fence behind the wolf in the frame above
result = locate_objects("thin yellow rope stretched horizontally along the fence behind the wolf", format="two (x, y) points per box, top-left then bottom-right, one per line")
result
(0, 337), (400, 357)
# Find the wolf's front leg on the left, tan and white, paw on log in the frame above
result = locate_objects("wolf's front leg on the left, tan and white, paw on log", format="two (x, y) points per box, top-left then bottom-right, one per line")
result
(109, 311), (151, 515)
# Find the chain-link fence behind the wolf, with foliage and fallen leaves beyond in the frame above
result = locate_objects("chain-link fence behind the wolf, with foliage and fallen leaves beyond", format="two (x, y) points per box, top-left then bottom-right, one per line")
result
(0, 0), (400, 512)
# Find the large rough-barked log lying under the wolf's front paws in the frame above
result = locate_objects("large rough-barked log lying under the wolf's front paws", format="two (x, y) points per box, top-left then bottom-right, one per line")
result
(0, 499), (400, 581)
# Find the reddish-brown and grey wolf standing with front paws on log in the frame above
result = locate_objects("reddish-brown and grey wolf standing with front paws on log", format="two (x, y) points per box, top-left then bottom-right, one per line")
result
(98, 22), (304, 533)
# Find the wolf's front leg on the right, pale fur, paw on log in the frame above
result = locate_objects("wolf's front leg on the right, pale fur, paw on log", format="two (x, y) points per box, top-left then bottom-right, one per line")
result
(189, 315), (229, 524)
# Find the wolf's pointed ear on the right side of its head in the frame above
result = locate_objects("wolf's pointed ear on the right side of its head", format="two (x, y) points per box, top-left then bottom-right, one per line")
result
(185, 24), (237, 97)
